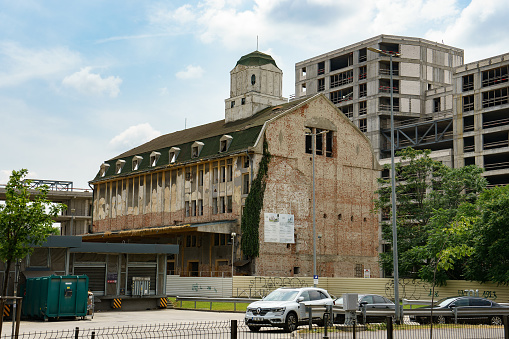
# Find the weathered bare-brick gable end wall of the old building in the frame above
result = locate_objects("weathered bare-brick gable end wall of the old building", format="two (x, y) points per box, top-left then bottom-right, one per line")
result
(255, 97), (379, 277)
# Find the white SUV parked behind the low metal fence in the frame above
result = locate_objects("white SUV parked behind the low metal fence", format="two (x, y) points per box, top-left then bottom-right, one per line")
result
(244, 287), (333, 332)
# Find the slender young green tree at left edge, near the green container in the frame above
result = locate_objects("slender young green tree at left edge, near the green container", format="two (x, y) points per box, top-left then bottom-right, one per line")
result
(0, 169), (65, 295)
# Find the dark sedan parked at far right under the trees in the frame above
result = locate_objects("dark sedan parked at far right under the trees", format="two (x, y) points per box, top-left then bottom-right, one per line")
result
(410, 297), (508, 325)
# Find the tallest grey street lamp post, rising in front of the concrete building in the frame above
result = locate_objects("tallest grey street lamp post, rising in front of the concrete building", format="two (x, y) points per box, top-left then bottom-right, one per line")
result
(368, 47), (401, 321)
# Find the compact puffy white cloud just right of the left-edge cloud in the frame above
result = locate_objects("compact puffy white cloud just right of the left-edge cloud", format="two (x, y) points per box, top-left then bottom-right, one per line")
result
(62, 67), (122, 98)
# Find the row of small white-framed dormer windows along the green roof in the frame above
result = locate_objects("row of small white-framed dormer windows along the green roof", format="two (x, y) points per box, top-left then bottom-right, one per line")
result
(100, 134), (233, 177)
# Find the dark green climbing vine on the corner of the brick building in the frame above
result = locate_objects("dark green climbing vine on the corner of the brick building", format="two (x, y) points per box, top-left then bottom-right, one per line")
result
(240, 141), (271, 258)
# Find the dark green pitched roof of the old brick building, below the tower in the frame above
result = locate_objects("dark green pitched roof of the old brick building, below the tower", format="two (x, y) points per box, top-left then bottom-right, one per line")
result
(91, 99), (306, 183)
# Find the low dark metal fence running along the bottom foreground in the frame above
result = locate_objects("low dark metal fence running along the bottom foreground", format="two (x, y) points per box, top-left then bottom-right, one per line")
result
(2, 316), (509, 339)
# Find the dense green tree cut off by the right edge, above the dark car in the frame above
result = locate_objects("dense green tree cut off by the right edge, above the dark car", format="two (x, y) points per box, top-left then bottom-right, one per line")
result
(465, 186), (509, 285)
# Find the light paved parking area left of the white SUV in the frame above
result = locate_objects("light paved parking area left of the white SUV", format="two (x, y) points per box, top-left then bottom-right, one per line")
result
(2, 309), (244, 335)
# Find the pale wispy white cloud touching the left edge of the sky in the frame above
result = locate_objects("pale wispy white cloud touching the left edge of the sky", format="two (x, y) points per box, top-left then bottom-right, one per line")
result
(0, 41), (81, 87)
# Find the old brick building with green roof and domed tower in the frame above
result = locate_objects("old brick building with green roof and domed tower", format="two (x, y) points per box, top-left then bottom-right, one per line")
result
(87, 51), (379, 277)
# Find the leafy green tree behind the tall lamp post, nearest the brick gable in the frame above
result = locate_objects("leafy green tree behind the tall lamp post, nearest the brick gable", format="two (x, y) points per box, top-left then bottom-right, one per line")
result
(375, 148), (487, 281)
